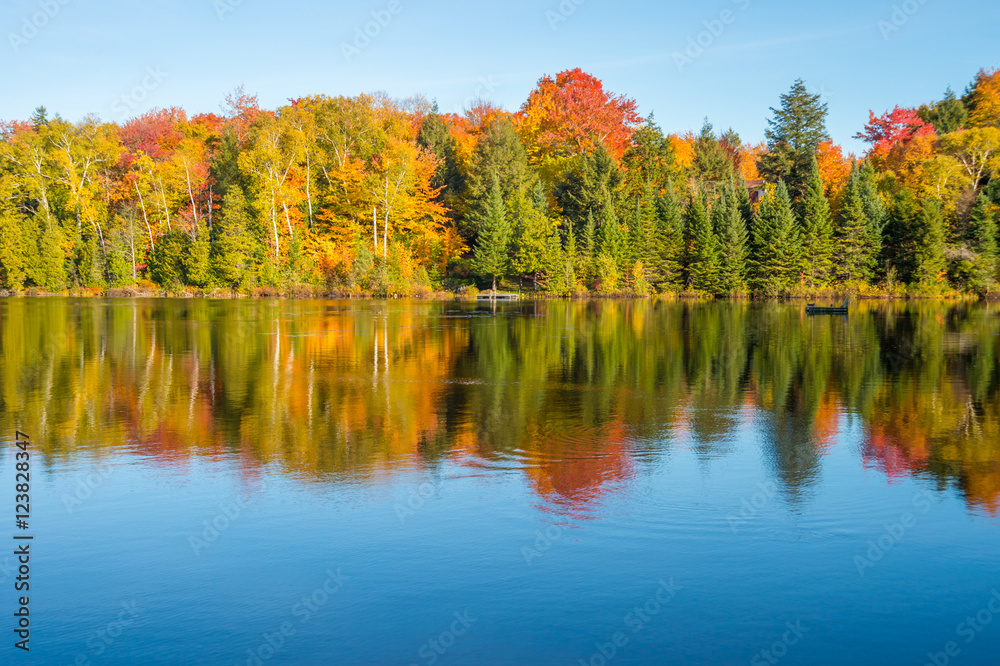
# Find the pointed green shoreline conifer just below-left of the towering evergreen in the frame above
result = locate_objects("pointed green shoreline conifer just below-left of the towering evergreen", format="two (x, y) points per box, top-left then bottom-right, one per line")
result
(750, 180), (800, 295)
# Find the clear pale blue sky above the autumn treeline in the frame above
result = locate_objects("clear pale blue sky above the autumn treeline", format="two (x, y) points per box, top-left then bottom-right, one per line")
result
(0, 0), (1000, 152)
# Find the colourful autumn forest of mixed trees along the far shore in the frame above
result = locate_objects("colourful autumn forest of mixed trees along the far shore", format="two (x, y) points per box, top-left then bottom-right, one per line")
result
(0, 69), (1000, 298)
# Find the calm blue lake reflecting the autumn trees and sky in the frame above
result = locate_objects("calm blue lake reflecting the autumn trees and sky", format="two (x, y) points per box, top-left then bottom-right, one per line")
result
(0, 298), (1000, 666)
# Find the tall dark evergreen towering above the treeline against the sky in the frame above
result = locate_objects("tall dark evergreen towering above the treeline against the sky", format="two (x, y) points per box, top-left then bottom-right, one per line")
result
(758, 79), (830, 199)
